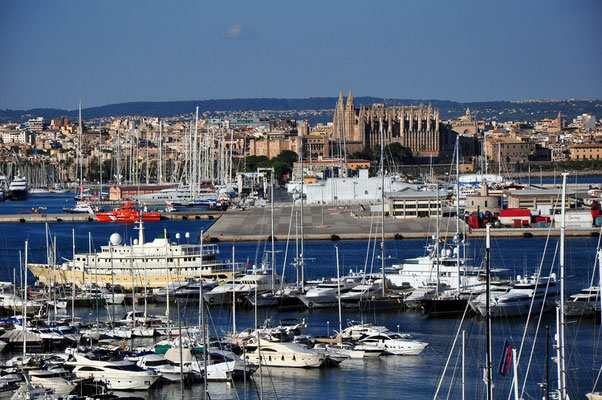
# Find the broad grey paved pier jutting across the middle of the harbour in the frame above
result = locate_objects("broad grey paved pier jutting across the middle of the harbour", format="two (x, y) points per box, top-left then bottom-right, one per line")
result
(206, 205), (600, 242)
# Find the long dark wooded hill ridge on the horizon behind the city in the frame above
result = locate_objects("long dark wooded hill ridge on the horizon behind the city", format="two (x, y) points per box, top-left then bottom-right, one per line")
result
(0, 96), (602, 122)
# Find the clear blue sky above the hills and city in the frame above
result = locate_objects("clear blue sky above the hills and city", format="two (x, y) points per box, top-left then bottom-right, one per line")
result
(0, 0), (602, 109)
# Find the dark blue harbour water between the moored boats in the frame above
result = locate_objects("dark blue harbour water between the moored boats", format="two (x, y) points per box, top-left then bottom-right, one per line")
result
(0, 196), (602, 400)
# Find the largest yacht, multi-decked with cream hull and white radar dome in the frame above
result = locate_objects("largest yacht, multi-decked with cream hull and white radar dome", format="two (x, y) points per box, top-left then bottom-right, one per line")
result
(27, 222), (244, 289)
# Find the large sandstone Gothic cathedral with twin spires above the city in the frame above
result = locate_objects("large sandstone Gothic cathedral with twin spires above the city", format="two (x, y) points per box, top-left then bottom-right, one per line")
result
(333, 90), (456, 157)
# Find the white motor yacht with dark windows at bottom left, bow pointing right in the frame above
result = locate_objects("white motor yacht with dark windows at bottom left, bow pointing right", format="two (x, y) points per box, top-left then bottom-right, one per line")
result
(65, 351), (159, 390)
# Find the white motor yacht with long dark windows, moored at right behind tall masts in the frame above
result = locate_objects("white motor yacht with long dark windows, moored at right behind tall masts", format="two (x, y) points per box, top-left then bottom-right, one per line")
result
(471, 274), (559, 317)
